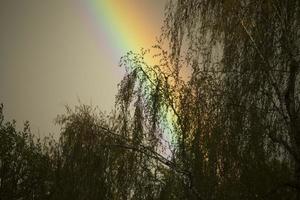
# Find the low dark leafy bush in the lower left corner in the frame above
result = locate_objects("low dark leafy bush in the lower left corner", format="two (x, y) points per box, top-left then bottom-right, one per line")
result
(0, 104), (52, 200)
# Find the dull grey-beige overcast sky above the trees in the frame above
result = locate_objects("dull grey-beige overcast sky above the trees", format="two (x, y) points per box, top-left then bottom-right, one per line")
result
(0, 0), (166, 136)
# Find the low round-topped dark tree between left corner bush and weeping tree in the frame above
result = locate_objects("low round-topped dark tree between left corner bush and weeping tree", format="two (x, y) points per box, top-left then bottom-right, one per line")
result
(53, 104), (166, 199)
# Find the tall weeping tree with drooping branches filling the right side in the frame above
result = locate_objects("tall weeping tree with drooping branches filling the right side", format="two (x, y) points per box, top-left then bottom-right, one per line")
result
(114, 0), (300, 199)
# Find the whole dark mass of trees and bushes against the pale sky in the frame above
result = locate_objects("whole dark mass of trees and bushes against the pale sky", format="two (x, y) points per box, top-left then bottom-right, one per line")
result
(0, 0), (300, 200)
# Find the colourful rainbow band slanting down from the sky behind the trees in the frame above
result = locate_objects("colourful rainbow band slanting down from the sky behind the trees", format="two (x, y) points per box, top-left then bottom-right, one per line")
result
(77, 0), (175, 144)
